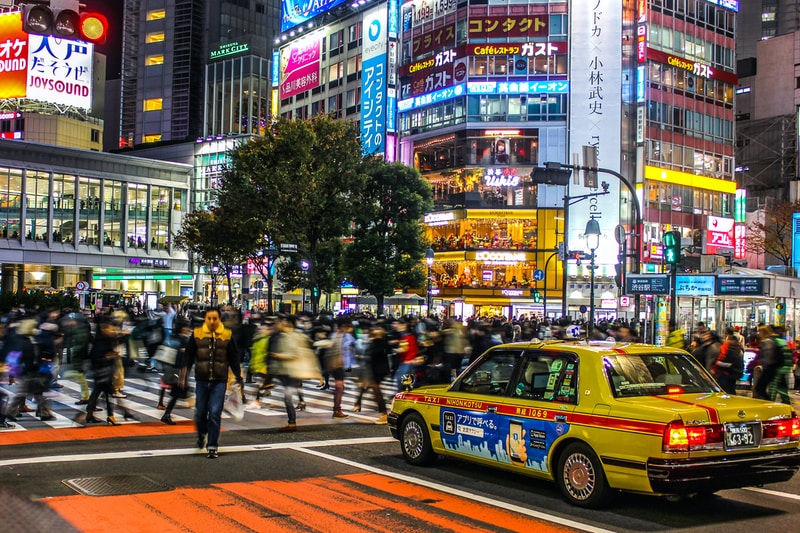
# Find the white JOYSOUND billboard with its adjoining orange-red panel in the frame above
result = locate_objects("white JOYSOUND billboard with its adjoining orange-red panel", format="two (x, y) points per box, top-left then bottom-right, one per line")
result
(0, 11), (94, 109)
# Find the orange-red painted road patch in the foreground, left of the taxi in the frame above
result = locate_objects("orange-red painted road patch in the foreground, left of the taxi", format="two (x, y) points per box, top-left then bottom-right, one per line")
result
(45, 474), (573, 533)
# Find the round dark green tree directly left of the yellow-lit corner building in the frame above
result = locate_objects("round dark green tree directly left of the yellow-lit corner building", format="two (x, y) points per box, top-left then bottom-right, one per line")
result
(344, 160), (433, 311)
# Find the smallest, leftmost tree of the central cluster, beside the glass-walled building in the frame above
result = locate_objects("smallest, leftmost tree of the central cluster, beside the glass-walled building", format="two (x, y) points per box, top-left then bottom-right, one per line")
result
(175, 207), (252, 304)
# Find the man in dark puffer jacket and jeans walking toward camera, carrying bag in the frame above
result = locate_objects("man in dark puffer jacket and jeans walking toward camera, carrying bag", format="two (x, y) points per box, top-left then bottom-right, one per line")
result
(186, 308), (243, 459)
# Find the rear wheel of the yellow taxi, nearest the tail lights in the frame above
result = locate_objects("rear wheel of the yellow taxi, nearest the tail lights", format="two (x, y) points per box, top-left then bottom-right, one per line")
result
(556, 442), (614, 509)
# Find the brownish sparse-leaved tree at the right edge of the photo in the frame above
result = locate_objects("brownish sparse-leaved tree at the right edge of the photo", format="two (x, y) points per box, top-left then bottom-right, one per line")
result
(746, 198), (800, 267)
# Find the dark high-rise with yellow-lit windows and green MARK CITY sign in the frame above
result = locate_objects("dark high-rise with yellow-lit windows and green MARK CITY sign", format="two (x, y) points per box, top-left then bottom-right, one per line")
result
(120, 0), (280, 148)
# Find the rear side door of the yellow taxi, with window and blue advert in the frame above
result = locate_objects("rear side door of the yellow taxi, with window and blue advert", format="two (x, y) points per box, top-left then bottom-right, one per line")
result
(497, 350), (578, 472)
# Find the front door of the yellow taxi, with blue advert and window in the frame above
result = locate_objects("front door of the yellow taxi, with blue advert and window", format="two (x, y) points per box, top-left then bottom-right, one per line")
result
(439, 349), (522, 461)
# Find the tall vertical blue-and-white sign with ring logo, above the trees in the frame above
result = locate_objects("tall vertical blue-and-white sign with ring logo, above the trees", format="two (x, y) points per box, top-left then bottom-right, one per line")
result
(361, 4), (389, 154)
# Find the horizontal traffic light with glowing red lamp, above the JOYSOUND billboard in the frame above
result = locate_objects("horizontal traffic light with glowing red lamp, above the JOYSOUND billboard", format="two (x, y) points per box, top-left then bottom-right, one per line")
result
(22, 0), (108, 44)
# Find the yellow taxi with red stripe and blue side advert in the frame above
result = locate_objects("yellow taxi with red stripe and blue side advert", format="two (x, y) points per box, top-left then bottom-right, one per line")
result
(389, 341), (800, 508)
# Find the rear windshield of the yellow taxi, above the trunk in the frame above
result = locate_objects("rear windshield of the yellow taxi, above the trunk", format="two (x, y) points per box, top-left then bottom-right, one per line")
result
(603, 353), (721, 398)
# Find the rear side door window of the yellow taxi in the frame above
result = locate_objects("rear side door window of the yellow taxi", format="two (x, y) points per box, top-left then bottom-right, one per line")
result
(512, 352), (578, 404)
